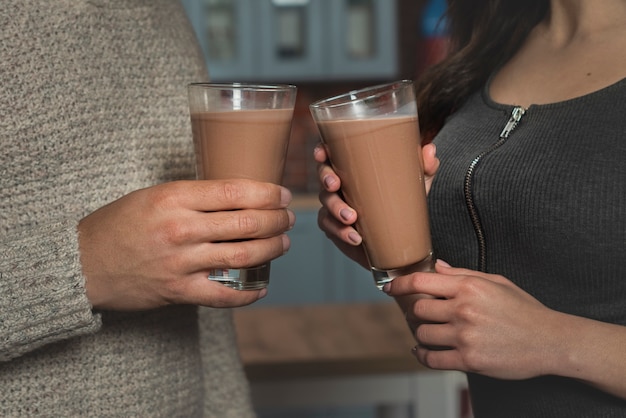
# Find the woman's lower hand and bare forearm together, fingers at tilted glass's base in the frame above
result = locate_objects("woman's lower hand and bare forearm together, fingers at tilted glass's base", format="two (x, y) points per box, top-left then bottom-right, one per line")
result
(383, 261), (626, 399)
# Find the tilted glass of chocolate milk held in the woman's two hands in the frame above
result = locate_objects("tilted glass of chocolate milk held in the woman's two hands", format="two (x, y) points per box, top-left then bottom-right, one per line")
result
(310, 80), (433, 288)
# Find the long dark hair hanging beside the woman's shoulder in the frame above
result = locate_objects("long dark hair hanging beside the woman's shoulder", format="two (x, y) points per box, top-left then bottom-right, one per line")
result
(416, 0), (549, 141)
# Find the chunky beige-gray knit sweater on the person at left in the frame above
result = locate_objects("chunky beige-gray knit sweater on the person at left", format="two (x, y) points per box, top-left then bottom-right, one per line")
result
(0, 0), (253, 418)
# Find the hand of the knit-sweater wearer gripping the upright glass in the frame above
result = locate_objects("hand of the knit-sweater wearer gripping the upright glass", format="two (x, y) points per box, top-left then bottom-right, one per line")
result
(78, 180), (295, 310)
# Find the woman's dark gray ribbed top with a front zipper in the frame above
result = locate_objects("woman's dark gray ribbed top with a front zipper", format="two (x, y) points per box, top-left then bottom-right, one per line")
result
(429, 76), (626, 418)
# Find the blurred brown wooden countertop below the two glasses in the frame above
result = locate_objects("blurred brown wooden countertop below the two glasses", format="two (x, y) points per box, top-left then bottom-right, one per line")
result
(234, 302), (424, 381)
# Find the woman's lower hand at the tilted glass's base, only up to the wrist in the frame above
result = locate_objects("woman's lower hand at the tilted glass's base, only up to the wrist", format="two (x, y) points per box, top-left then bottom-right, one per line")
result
(384, 261), (559, 379)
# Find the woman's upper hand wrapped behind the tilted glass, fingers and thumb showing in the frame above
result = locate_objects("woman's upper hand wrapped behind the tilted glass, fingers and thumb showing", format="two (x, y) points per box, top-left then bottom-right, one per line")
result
(314, 143), (439, 268)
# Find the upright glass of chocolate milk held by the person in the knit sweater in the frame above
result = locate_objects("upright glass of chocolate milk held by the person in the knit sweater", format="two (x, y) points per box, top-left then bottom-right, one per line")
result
(188, 83), (297, 290)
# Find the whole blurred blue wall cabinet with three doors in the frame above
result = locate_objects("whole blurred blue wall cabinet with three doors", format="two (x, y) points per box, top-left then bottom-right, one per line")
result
(182, 0), (398, 83)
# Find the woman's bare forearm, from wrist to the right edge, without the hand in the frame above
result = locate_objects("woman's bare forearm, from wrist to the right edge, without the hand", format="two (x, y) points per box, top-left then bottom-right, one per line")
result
(548, 314), (626, 399)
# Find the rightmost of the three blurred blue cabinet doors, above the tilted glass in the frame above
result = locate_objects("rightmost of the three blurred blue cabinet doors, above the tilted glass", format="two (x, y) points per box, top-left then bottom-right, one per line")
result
(329, 0), (398, 79)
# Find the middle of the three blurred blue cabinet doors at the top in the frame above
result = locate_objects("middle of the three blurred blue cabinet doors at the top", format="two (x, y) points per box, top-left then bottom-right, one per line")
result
(256, 0), (328, 82)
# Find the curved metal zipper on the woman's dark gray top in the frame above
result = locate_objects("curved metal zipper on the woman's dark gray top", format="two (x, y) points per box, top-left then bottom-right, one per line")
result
(463, 106), (526, 271)
